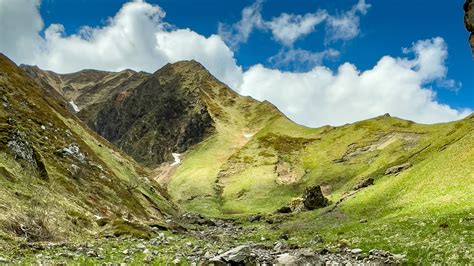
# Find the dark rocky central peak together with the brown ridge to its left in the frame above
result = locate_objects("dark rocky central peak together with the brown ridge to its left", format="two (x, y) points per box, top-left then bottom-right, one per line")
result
(22, 61), (279, 166)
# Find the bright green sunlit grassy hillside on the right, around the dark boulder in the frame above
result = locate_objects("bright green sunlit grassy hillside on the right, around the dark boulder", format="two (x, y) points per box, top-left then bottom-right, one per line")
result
(168, 107), (474, 264)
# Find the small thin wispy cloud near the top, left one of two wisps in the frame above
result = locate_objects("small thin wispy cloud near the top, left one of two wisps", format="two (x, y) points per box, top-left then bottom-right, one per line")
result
(265, 10), (328, 46)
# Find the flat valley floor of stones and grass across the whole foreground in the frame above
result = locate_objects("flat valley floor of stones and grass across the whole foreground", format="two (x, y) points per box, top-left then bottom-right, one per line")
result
(0, 210), (474, 265)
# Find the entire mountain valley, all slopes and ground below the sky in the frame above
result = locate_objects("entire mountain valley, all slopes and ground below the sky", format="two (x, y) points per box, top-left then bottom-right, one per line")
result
(0, 51), (474, 265)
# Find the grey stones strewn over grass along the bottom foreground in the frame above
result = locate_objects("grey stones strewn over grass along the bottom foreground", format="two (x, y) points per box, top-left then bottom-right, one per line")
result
(0, 214), (405, 265)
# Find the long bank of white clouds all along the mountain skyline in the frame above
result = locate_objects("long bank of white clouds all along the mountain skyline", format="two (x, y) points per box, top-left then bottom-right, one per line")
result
(0, 0), (471, 126)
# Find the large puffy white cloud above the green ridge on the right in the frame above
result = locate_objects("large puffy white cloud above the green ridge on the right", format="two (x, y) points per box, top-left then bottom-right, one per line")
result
(241, 37), (472, 126)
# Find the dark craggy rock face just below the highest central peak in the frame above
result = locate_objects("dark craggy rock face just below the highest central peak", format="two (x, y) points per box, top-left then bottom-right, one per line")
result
(89, 61), (214, 166)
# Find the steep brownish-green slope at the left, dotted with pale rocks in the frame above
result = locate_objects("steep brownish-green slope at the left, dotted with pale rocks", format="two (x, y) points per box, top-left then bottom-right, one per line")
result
(0, 55), (175, 244)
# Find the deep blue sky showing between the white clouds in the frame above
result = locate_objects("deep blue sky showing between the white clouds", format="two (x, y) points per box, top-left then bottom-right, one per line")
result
(41, 0), (474, 108)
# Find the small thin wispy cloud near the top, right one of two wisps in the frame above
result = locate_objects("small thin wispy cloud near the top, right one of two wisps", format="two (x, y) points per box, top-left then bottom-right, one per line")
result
(326, 0), (370, 42)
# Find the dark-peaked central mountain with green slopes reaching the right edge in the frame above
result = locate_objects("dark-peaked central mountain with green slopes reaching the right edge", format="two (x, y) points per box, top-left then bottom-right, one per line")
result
(22, 61), (474, 263)
